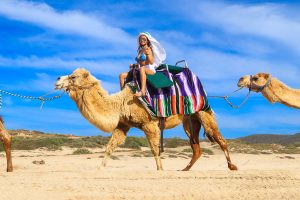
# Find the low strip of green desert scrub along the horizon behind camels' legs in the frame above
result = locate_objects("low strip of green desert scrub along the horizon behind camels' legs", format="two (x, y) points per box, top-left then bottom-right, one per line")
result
(0, 130), (300, 157)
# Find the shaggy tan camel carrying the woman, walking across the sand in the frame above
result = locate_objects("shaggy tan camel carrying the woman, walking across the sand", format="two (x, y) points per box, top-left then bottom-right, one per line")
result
(55, 68), (237, 171)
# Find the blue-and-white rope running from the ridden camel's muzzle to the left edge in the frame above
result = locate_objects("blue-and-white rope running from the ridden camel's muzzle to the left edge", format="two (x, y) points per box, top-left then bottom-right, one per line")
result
(0, 90), (65, 109)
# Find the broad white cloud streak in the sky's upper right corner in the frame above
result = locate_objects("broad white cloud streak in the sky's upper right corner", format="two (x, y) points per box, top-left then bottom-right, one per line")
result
(183, 1), (300, 52)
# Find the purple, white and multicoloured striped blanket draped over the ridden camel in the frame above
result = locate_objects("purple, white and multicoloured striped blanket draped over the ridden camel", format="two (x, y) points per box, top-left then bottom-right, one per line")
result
(133, 68), (211, 117)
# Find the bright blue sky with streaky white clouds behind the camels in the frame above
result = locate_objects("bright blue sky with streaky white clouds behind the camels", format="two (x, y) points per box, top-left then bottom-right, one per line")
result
(0, 0), (300, 138)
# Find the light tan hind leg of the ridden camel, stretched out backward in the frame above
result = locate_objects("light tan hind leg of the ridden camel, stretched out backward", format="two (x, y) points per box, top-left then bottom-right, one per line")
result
(197, 111), (237, 170)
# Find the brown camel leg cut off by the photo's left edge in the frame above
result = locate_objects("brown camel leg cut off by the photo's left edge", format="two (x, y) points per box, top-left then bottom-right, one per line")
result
(0, 116), (13, 172)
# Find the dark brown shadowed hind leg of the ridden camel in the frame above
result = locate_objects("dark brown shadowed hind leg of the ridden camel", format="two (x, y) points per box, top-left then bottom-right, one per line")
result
(182, 116), (202, 171)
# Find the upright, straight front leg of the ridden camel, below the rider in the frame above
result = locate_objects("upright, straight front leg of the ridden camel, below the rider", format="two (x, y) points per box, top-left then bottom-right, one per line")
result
(142, 123), (163, 170)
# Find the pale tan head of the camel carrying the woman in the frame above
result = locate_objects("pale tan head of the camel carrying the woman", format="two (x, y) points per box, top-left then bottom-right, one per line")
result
(55, 68), (99, 93)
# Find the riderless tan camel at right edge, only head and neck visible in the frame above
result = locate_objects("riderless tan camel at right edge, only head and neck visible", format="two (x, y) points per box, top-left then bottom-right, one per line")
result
(237, 73), (300, 109)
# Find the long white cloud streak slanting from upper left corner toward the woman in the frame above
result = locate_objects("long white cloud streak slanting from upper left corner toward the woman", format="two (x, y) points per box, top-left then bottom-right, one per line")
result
(0, 0), (135, 45)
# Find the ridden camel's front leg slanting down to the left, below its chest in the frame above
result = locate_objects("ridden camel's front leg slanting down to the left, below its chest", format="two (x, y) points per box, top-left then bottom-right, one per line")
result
(100, 126), (129, 169)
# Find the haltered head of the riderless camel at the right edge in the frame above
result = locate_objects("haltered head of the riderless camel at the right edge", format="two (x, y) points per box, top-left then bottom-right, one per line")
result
(237, 73), (271, 92)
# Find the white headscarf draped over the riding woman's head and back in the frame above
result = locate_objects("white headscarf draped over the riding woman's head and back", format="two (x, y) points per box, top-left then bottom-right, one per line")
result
(137, 32), (167, 67)
